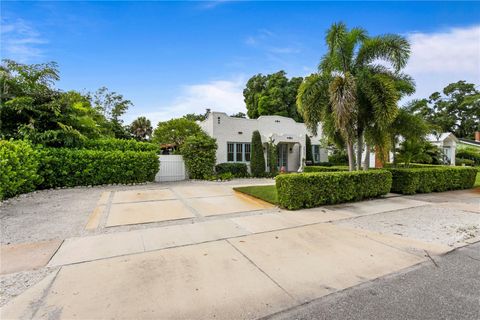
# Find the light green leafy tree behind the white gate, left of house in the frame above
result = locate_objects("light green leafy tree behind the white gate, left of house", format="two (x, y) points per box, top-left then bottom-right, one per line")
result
(152, 118), (203, 147)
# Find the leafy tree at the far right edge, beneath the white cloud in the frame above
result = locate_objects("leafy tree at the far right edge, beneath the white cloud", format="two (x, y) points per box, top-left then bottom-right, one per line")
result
(408, 81), (480, 139)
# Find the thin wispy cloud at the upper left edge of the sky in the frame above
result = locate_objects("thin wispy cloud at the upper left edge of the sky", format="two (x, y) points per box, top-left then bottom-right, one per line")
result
(0, 18), (47, 63)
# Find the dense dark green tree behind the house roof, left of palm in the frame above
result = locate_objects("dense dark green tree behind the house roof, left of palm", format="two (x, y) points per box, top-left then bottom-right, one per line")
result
(243, 70), (303, 122)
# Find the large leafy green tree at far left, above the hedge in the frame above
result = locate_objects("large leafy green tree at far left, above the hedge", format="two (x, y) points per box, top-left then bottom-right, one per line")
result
(0, 60), (106, 146)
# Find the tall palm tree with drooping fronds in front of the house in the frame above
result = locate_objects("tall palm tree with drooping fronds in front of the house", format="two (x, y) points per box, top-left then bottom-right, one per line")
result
(297, 23), (414, 170)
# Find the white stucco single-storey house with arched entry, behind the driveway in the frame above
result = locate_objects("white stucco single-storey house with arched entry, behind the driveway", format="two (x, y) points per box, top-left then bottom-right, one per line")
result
(198, 112), (328, 171)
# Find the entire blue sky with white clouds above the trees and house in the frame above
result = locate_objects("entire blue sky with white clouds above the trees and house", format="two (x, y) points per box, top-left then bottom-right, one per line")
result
(1, 1), (480, 124)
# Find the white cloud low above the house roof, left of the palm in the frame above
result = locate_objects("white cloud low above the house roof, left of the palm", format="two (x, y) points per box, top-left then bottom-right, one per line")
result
(133, 76), (246, 125)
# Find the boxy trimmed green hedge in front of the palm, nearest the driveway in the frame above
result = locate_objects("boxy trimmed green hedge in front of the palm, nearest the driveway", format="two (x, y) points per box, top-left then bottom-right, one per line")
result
(275, 170), (392, 209)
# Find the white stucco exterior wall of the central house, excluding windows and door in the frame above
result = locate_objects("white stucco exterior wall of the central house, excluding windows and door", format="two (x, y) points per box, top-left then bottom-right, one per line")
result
(198, 112), (328, 171)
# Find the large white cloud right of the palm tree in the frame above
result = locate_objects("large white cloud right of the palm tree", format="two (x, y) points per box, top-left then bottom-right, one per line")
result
(405, 25), (480, 98)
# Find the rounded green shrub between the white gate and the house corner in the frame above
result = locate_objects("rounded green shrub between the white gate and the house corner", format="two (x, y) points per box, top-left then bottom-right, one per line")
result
(180, 133), (217, 179)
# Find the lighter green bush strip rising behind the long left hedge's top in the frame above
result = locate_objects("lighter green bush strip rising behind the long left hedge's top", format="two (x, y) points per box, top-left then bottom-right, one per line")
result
(82, 138), (160, 153)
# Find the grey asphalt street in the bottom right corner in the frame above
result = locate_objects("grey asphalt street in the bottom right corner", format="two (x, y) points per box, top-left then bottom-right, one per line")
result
(267, 242), (480, 320)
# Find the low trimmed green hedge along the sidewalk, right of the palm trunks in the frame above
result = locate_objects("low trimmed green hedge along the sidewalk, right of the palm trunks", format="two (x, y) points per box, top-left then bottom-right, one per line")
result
(388, 166), (477, 194)
